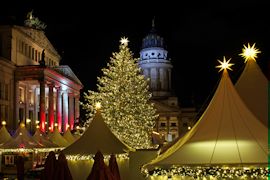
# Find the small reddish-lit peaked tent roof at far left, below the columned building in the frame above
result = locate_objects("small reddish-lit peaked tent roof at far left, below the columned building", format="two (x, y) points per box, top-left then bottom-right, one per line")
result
(0, 124), (44, 149)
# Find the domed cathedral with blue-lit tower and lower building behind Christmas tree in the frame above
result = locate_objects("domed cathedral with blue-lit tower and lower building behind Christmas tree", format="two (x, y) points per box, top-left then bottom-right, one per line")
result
(139, 19), (196, 142)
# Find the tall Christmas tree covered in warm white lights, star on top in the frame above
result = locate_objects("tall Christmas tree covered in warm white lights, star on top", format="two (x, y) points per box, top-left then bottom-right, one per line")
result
(83, 38), (158, 149)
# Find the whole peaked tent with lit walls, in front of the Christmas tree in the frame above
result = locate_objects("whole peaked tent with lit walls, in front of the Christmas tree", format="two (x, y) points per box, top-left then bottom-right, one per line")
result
(63, 110), (131, 179)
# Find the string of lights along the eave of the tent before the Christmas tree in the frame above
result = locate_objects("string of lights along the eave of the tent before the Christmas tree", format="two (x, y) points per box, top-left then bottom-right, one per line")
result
(66, 153), (129, 161)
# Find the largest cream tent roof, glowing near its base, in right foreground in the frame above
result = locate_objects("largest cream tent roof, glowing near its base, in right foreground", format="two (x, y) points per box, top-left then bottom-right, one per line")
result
(144, 70), (268, 170)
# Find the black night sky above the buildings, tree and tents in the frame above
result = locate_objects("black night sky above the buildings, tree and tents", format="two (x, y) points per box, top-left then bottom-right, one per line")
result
(0, 1), (270, 106)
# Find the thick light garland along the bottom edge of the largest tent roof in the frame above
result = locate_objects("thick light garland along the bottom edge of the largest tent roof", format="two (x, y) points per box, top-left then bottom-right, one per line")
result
(142, 166), (269, 179)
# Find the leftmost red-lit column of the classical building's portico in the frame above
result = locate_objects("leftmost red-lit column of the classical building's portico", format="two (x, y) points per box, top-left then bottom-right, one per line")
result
(39, 79), (46, 132)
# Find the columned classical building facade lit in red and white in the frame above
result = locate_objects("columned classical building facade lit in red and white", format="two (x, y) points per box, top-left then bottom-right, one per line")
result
(0, 25), (83, 132)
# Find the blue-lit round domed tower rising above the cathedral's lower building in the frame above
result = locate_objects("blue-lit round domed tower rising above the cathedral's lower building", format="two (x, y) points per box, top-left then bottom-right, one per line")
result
(139, 20), (173, 98)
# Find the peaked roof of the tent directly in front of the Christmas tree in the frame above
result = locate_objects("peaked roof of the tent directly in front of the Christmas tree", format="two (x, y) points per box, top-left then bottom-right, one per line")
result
(63, 110), (132, 155)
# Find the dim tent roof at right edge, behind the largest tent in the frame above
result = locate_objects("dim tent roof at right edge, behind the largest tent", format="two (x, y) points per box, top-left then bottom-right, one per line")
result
(235, 60), (269, 127)
